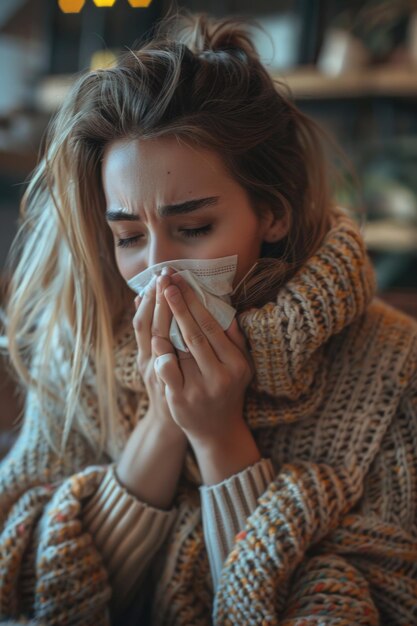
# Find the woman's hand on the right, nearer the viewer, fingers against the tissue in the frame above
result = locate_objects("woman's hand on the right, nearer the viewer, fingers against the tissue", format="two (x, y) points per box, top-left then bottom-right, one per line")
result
(155, 274), (253, 444)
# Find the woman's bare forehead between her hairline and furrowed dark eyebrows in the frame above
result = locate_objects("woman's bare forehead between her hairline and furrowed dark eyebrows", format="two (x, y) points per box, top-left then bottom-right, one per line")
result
(102, 137), (232, 203)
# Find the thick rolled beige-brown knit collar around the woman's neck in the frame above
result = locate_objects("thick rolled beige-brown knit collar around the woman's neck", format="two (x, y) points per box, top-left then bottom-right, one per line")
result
(116, 214), (375, 420)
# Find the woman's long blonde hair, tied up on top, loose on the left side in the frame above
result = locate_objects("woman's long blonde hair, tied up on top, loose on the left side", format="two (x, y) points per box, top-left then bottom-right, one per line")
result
(0, 12), (344, 456)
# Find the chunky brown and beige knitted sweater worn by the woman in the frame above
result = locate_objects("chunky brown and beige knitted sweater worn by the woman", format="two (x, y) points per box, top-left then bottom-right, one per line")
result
(0, 212), (417, 626)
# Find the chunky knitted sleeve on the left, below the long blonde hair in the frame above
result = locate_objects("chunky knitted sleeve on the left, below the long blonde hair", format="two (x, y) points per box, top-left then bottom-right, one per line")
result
(0, 392), (111, 626)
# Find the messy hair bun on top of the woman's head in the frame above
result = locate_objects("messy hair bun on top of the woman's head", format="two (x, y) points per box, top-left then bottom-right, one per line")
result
(159, 9), (259, 60)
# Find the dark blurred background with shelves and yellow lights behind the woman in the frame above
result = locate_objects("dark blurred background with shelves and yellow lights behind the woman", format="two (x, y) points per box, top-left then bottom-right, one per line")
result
(0, 0), (417, 455)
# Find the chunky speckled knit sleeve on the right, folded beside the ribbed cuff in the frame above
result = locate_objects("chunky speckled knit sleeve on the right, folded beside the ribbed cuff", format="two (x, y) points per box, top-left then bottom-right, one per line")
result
(214, 378), (417, 626)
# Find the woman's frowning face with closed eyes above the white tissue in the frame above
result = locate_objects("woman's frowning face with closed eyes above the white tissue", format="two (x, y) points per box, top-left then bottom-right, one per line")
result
(102, 137), (276, 286)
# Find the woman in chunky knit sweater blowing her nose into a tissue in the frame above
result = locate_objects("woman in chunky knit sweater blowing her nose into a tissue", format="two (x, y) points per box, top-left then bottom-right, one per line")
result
(0, 9), (417, 626)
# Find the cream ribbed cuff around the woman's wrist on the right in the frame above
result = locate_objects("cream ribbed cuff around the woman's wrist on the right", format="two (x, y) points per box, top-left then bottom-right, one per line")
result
(200, 459), (274, 589)
